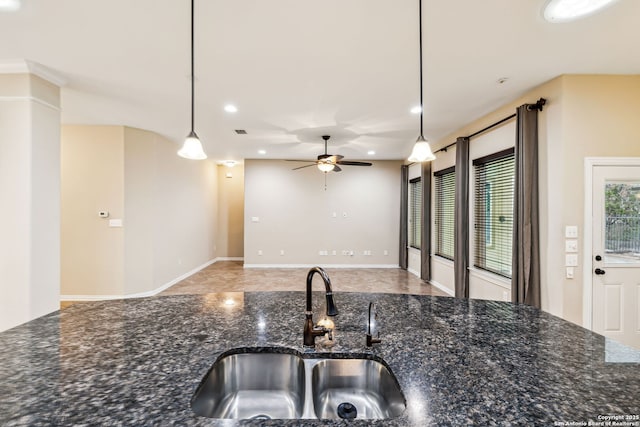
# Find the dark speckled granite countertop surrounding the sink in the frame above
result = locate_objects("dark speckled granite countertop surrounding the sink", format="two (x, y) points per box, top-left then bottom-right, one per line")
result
(0, 292), (640, 426)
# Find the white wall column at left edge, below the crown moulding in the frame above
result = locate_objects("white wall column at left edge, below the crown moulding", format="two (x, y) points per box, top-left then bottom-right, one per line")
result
(0, 74), (60, 331)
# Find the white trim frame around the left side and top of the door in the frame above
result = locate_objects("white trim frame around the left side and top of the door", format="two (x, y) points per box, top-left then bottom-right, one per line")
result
(582, 157), (640, 330)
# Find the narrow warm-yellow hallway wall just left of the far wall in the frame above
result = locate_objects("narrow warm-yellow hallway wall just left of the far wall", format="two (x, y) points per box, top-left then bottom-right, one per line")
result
(216, 164), (244, 258)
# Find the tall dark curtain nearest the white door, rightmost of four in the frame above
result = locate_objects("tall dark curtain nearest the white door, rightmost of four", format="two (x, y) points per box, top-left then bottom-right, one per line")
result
(511, 104), (540, 308)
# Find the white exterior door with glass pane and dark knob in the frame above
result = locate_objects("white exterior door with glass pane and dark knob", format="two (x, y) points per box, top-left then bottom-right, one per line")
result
(591, 166), (640, 349)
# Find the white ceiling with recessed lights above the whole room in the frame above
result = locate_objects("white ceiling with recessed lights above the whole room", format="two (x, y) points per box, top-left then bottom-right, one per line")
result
(0, 0), (640, 160)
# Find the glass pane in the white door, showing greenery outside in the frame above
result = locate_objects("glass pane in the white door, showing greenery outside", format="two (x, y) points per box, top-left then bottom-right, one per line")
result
(604, 181), (640, 264)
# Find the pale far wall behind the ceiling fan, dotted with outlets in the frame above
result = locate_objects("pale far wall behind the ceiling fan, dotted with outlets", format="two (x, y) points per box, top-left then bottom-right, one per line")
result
(244, 160), (401, 266)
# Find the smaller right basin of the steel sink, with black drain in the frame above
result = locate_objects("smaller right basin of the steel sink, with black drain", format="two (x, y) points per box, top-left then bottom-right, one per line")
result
(311, 359), (406, 419)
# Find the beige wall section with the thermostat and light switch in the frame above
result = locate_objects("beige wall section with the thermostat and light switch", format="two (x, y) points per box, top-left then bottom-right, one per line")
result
(60, 126), (125, 295)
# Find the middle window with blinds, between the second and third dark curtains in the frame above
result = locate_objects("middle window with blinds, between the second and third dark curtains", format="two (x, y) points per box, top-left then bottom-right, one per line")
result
(434, 167), (456, 260)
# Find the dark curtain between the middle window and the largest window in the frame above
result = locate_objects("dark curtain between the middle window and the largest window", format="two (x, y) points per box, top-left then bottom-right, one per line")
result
(453, 137), (469, 298)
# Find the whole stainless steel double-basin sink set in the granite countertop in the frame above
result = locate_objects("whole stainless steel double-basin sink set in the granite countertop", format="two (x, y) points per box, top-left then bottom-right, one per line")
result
(191, 349), (406, 419)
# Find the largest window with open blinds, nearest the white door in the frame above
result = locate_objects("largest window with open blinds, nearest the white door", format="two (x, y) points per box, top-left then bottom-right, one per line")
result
(473, 149), (515, 278)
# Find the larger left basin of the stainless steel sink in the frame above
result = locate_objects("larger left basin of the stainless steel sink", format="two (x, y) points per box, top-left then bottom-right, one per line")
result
(191, 353), (305, 419)
